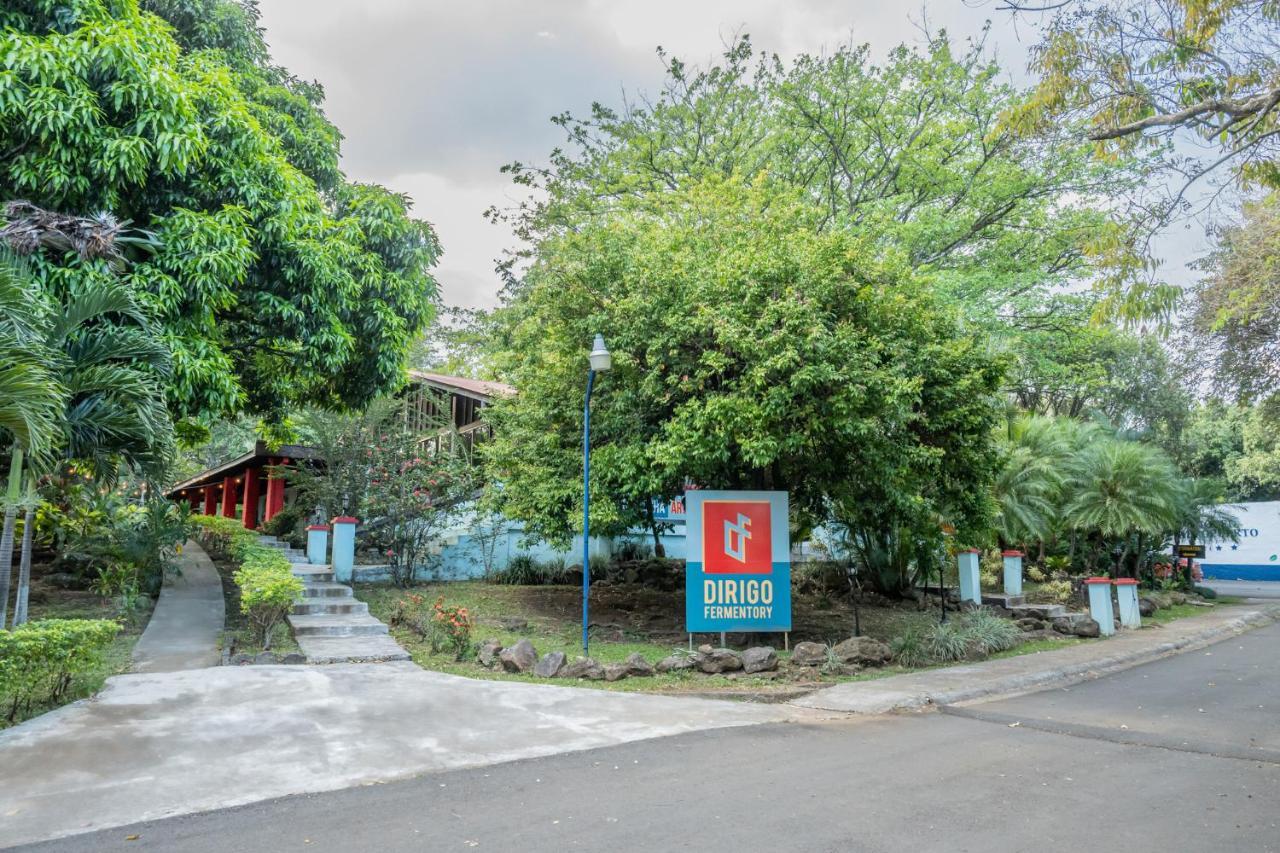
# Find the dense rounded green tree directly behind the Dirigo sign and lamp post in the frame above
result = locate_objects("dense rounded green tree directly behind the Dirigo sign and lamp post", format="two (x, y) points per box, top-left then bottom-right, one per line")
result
(480, 175), (1001, 558)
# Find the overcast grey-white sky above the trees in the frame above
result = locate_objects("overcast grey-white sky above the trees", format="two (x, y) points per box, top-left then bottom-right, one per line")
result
(261, 0), (1204, 307)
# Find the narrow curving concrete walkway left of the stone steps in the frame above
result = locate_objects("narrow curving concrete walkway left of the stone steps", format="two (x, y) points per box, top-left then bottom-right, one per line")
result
(132, 540), (227, 672)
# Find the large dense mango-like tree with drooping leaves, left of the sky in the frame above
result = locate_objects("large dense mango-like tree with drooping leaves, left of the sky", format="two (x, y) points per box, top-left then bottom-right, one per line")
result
(0, 0), (439, 432)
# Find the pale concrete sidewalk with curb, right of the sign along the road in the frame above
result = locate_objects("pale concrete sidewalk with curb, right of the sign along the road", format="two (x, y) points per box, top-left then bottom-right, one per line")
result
(791, 605), (1280, 713)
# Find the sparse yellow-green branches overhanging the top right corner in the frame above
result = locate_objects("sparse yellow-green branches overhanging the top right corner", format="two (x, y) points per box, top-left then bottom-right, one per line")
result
(1005, 0), (1280, 189)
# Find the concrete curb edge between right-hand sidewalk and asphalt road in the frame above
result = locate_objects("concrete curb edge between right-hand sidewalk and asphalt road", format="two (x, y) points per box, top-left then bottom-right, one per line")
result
(792, 606), (1280, 715)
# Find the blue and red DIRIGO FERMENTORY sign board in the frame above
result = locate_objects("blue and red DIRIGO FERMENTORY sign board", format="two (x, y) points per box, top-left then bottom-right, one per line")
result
(685, 489), (791, 634)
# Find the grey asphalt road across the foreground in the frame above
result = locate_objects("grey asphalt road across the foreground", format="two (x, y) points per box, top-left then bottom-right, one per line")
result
(20, 625), (1280, 853)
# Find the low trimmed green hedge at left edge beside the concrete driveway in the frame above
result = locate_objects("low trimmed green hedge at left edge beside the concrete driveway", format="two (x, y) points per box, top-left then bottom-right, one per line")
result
(0, 619), (120, 722)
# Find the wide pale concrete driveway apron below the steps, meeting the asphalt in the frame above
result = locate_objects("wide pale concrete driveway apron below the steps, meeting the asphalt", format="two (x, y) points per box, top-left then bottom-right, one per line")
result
(0, 662), (804, 849)
